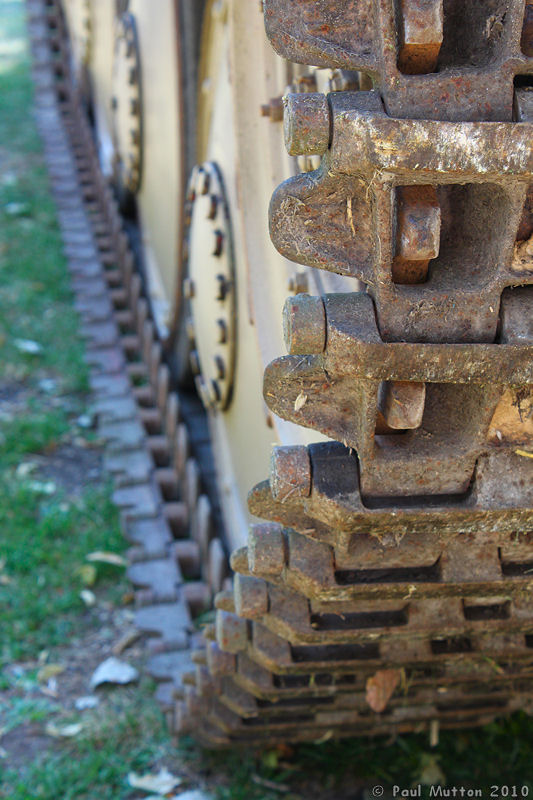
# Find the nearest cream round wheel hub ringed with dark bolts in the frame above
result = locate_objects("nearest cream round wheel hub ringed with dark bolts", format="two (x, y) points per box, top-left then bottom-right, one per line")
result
(184, 162), (236, 410)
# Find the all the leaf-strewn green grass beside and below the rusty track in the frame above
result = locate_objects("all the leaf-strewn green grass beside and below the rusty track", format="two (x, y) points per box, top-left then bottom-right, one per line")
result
(0, 0), (533, 800)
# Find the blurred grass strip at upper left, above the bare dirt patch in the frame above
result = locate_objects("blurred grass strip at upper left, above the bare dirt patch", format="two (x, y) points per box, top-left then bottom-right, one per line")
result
(0, 2), (87, 393)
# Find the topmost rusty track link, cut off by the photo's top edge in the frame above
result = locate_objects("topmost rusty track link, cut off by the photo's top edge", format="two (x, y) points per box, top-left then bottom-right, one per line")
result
(263, 0), (533, 120)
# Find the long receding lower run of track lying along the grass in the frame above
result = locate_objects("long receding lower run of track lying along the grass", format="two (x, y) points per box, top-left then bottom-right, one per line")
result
(27, 0), (231, 726)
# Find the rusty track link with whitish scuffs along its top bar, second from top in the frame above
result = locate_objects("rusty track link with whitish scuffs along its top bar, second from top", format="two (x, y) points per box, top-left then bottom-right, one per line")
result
(270, 92), (533, 342)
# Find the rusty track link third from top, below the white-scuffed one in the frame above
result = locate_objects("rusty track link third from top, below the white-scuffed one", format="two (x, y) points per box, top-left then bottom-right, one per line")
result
(264, 294), (533, 499)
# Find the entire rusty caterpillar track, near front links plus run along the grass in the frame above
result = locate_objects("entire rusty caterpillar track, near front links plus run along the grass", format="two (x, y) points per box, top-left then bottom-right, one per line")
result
(30, 0), (533, 746)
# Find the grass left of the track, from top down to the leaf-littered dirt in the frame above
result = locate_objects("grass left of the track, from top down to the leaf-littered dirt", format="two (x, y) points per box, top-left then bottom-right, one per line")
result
(0, 2), (120, 662)
